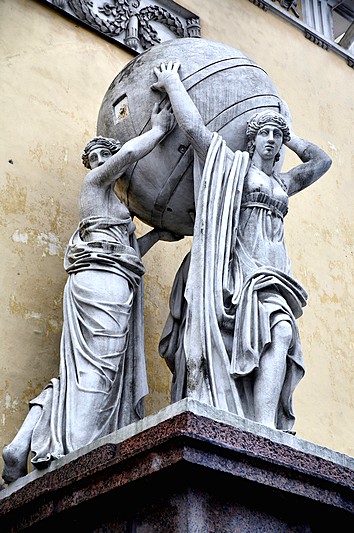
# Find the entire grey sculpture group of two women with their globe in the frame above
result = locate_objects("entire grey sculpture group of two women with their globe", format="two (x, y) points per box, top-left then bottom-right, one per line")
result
(3, 38), (331, 482)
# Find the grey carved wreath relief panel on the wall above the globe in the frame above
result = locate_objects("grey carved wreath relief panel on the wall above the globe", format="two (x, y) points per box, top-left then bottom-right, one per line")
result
(45, 0), (200, 52)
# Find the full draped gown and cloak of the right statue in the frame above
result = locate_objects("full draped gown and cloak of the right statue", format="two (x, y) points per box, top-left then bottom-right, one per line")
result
(160, 133), (307, 430)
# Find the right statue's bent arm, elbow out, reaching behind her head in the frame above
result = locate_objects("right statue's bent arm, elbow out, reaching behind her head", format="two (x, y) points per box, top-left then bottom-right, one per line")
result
(282, 133), (332, 196)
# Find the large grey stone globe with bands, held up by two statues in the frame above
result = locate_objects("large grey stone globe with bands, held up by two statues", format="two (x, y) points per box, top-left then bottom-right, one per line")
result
(97, 38), (286, 235)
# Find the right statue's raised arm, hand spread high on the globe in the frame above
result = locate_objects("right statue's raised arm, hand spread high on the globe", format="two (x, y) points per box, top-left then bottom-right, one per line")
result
(152, 61), (212, 160)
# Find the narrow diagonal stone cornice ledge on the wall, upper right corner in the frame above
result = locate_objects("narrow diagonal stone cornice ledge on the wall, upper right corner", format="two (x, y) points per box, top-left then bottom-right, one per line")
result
(249, 0), (354, 68)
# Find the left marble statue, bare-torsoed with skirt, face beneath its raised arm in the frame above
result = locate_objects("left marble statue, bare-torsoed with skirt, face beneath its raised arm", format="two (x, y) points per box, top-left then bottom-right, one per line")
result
(3, 100), (180, 483)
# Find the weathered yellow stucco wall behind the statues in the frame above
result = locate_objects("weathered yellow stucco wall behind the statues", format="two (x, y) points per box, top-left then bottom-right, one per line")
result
(0, 0), (354, 476)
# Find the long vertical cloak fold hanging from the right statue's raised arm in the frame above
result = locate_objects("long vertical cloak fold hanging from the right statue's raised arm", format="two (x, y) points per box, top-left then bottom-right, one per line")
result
(184, 134), (248, 415)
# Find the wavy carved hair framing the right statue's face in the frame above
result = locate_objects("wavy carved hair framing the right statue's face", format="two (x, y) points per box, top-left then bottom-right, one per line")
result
(246, 110), (290, 162)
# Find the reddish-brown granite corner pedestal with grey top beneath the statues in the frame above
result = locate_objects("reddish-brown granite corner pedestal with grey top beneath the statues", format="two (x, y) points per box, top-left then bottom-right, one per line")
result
(0, 400), (354, 533)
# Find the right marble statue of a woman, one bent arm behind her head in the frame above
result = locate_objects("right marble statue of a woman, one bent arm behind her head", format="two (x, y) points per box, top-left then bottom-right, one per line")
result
(152, 62), (331, 431)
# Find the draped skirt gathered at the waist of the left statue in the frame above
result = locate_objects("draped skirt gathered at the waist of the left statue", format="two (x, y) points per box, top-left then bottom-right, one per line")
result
(31, 211), (148, 465)
